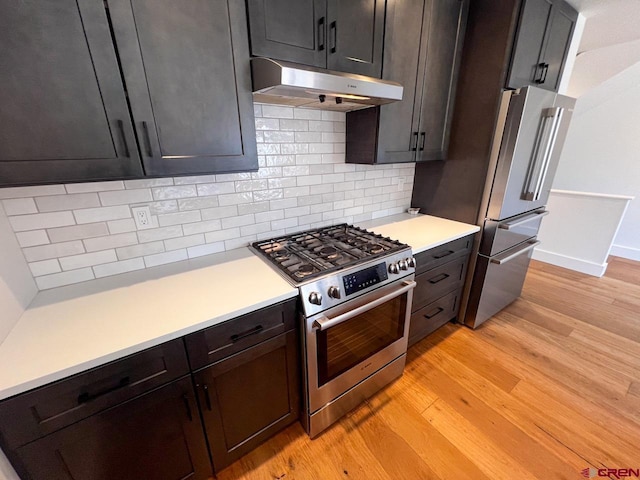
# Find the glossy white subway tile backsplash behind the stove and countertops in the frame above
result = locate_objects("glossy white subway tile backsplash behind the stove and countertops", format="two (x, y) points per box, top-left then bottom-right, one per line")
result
(5, 104), (415, 289)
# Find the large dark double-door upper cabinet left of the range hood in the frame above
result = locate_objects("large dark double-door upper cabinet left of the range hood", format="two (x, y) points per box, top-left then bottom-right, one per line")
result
(0, 0), (258, 186)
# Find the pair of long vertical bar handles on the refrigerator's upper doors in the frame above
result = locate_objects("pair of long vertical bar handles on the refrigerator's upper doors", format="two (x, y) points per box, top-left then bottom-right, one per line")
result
(522, 107), (564, 202)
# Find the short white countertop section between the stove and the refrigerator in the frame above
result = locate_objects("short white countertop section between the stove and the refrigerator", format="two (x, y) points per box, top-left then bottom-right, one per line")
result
(358, 213), (480, 255)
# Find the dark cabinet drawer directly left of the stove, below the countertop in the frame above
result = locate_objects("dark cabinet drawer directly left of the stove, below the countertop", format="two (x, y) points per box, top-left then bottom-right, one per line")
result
(185, 299), (296, 370)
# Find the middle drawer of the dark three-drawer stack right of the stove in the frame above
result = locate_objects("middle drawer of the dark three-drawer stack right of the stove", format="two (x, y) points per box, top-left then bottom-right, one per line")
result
(411, 256), (467, 311)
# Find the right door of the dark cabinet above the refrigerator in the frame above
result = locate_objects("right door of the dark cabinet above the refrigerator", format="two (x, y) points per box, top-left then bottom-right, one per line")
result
(538, 2), (577, 92)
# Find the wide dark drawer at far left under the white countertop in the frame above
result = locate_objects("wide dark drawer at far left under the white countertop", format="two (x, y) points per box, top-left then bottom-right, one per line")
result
(0, 339), (189, 448)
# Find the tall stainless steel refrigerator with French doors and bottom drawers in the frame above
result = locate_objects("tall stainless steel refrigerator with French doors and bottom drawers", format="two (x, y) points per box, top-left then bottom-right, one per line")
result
(459, 87), (575, 328)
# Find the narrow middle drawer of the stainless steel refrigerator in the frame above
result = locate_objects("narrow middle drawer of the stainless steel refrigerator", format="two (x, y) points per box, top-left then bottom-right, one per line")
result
(480, 208), (549, 257)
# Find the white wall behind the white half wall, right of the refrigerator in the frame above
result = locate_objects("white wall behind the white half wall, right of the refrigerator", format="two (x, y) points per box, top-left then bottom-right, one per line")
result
(553, 63), (640, 260)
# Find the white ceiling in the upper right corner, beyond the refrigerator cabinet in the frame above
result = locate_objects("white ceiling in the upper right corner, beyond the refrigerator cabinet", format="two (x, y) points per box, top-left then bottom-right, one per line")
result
(567, 0), (640, 97)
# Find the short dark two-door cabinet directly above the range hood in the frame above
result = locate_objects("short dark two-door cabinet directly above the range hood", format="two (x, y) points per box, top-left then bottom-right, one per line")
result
(247, 0), (386, 78)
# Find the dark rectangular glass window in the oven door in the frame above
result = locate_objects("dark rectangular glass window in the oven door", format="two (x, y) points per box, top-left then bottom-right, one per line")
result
(316, 294), (407, 386)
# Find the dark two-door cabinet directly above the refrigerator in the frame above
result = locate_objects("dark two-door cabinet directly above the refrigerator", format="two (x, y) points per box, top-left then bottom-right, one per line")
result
(507, 0), (578, 91)
